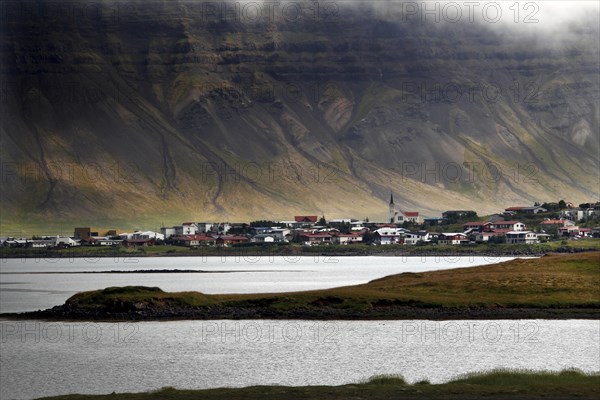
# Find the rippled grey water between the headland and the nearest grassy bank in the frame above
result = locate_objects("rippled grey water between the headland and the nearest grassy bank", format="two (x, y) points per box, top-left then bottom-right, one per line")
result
(0, 320), (600, 399)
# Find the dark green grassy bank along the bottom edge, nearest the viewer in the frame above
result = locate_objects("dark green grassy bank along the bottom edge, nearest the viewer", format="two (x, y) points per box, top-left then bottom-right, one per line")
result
(36, 370), (600, 400)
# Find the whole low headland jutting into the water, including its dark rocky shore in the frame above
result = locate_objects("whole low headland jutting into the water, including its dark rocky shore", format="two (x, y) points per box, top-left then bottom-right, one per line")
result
(4, 252), (600, 320)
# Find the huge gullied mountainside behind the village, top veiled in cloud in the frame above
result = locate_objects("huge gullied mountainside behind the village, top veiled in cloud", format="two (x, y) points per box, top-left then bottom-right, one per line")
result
(0, 1), (600, 231)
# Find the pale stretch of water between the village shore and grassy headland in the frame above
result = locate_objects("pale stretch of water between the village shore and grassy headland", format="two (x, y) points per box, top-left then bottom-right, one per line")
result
(0, 255), (512, 312)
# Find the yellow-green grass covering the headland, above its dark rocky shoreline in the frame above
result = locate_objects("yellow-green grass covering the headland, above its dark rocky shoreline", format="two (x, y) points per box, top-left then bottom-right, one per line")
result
(67, 252), (600, 312)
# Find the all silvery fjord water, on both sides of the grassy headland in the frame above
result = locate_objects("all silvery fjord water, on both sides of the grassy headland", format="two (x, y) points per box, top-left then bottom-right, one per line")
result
(0, 256), (600, 399)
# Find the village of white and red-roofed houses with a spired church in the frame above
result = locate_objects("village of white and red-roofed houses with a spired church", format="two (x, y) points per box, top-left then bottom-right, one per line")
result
(0, 194), (600, 249)
